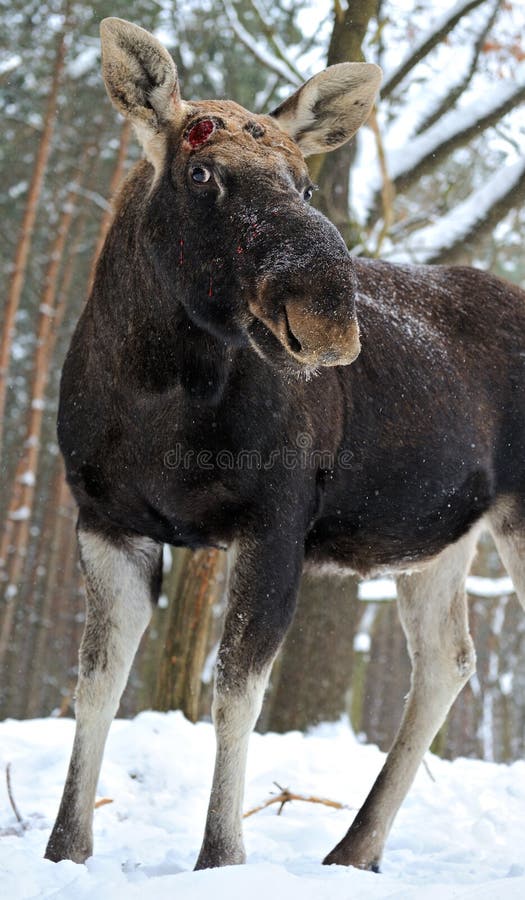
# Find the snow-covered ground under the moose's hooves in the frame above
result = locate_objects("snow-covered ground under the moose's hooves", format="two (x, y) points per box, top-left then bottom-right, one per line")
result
(0, 712), (525, 900)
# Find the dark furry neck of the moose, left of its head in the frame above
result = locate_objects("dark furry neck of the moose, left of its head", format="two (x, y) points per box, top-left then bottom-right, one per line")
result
(89, 163), (235, 404)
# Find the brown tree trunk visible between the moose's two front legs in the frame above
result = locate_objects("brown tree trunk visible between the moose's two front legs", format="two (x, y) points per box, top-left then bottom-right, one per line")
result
(155, 549), (227, 722)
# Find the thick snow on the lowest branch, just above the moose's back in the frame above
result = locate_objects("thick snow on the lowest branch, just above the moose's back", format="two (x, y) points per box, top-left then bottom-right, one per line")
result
(389, 157), (525, 264)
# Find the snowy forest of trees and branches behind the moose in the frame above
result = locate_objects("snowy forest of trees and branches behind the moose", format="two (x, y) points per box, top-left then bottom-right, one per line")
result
(0, 0), (525, 760)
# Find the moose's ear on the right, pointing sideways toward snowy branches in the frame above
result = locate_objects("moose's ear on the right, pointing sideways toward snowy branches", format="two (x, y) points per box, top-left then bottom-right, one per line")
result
(270, 63), (382, 156)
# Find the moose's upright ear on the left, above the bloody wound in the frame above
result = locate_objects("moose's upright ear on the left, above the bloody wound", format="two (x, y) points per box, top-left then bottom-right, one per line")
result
(100, 18), (182, 150)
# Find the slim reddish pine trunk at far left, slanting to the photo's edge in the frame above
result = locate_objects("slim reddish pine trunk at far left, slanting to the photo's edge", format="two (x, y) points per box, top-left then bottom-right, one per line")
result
(0, 0), (70, 459)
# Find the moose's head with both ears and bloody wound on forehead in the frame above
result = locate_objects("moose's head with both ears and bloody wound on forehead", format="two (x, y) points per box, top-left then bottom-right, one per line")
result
(101, 18), (380, 373)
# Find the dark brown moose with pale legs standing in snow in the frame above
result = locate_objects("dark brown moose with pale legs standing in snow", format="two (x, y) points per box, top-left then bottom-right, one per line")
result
(46, 18), (525, 870)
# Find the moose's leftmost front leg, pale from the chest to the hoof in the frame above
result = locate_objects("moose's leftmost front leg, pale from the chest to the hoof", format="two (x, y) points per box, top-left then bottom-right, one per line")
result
(45, 525), (161, 862)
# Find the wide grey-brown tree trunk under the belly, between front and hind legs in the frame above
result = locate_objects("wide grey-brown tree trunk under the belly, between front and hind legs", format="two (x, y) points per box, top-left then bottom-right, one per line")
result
(258, 575), (359, 732)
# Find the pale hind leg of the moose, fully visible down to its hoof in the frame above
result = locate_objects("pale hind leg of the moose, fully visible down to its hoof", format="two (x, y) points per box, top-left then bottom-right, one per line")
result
(324, 532), (477, 871)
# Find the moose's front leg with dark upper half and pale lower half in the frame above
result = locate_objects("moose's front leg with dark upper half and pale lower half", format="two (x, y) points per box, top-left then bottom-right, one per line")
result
(195, 528), (303, 869)
